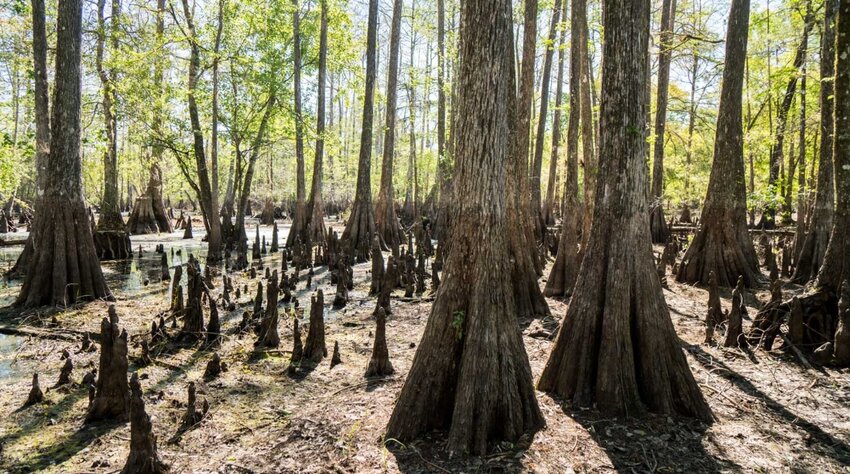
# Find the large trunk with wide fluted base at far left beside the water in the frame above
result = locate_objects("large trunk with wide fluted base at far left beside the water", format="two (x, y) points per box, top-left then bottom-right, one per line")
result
(16, 0), (112, 306)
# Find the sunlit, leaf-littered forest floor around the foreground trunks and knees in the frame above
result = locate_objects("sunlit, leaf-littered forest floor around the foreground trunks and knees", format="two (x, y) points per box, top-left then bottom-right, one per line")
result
(0, 223), (850, 473)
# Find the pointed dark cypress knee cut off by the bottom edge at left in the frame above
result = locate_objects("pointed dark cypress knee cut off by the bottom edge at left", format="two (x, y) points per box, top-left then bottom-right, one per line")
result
(121, 372), (168, 474)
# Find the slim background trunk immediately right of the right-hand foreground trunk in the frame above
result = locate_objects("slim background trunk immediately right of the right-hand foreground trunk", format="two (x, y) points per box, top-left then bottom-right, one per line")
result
(649, 0), (676, 244)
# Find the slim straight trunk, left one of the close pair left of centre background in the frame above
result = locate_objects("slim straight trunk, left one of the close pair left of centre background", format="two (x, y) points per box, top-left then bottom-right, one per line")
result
(286, 0), (308, 247)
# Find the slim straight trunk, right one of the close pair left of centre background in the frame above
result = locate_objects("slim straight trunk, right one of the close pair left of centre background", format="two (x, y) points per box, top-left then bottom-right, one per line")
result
(306, 0), (328, 243)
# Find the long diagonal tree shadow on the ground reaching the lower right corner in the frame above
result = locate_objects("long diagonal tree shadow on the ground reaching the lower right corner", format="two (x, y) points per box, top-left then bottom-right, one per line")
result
(685, 345), (850, 466)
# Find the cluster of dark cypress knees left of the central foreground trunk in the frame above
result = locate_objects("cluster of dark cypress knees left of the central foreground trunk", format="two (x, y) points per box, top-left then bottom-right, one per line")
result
(24, 220), (440, 474)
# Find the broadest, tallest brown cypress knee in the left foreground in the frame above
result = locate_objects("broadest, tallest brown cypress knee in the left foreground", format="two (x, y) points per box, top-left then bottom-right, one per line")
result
(85, 305), (130, 423)
